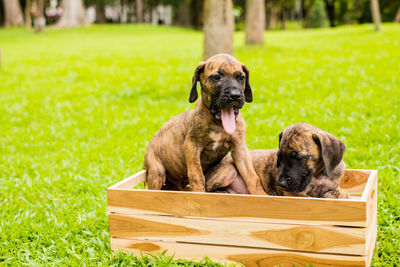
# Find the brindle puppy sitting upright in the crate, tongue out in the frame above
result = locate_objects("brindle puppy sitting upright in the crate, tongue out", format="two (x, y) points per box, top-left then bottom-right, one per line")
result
(144, 54), (265, 194)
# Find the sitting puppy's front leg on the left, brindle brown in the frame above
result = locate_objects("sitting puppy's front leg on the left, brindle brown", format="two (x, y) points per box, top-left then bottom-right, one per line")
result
(183, 137), (206, 192)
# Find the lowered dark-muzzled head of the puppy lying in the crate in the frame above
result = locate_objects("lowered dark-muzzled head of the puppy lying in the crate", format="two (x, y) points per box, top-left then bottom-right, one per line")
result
(277, 123), (346, 193)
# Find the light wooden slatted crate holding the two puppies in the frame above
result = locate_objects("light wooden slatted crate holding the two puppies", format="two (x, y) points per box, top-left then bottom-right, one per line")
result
(107, 170), (377, 266)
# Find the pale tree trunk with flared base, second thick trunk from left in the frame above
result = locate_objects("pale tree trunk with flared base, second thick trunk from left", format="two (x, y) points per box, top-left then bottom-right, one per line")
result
(57, 0), (88, 28)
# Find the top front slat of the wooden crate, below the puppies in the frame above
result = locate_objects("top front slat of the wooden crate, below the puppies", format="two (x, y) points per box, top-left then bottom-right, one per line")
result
(107, 188), (366, 227)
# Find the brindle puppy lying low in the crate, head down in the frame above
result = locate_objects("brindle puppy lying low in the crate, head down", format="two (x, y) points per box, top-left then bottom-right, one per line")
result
(206, 123), (349, 198)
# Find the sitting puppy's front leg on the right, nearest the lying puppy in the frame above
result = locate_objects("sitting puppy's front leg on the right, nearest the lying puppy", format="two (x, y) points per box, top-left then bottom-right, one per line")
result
(232, 141), (266, 195)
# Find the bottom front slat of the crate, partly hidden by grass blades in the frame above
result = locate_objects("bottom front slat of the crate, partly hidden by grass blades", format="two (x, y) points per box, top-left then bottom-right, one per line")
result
(111, 238), (366, 267)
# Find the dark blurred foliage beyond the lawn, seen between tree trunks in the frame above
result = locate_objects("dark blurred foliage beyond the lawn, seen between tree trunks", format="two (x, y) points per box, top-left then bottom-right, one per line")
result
(0, 0), (400, 30)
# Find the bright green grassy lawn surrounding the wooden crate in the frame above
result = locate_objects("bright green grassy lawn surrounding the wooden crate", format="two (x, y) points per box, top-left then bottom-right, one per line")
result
(0, 24), (400, 266)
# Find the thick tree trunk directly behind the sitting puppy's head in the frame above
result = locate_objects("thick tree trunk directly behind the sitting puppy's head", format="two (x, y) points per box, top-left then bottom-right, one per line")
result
(204, 0), (234, 60)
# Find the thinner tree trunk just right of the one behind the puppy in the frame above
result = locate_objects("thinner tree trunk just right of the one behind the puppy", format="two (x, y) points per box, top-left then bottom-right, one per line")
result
(246, 0), (265, 44)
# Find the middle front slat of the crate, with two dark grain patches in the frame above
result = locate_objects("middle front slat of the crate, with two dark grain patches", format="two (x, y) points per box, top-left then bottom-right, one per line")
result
(109, 213), (366, 255)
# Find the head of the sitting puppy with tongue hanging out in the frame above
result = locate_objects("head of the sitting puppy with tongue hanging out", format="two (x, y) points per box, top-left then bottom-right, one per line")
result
(189, 54), (253, 133)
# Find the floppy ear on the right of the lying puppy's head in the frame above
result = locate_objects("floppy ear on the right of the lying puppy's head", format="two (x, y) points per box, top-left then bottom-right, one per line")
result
(312, 131), (346, 177)
